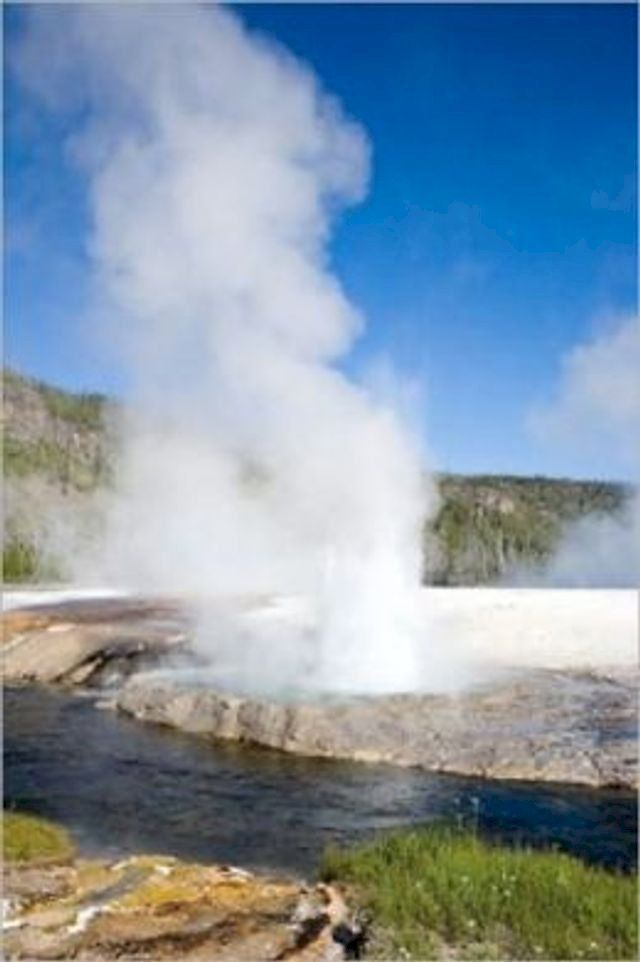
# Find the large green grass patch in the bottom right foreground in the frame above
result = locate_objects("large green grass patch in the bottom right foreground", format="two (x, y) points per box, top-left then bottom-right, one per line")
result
(321, 826), (638, 960)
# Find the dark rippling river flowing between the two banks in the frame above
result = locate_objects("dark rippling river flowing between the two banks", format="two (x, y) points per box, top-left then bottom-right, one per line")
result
(4, 688), (637, 874)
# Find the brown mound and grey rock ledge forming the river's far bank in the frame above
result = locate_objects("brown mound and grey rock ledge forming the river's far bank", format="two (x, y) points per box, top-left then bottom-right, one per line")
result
(3, 598), (638, 788)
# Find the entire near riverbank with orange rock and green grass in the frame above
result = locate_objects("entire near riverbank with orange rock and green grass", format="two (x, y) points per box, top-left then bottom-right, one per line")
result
(3, 813), (637, 962)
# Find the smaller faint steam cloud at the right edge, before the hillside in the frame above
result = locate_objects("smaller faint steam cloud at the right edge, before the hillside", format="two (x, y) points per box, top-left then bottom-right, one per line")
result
(520, 316), (640, 588)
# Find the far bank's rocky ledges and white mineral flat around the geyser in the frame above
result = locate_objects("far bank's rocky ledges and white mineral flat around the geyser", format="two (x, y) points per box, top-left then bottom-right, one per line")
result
(5, 589), (637, 787)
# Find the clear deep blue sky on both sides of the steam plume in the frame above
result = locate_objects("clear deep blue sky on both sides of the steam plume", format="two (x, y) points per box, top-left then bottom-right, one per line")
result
(5, 4), (637, 476)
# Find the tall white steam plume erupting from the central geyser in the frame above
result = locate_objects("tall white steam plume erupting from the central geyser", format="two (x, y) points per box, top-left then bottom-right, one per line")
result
(15, 5), (440, 691)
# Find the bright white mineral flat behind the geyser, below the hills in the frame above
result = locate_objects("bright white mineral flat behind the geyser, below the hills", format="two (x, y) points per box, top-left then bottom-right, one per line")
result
(3, 588), (638, 668)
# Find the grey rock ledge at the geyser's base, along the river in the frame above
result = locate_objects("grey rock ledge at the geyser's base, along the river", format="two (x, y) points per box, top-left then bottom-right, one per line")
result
(116, 669), (637, 788)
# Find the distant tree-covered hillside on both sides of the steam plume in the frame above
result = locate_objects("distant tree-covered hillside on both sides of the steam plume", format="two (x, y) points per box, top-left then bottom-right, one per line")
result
(3, 370), (630, 585)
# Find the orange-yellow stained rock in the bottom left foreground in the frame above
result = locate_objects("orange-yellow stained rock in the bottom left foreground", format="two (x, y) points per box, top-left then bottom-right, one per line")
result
(4, 856), (351, 962)
